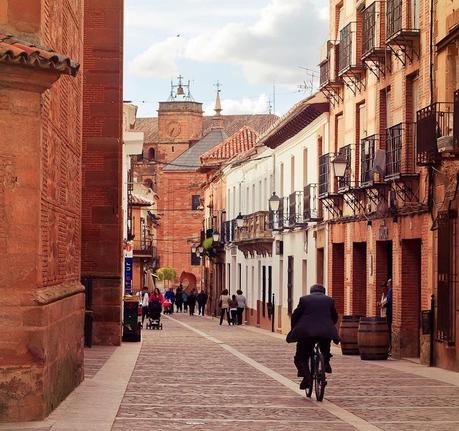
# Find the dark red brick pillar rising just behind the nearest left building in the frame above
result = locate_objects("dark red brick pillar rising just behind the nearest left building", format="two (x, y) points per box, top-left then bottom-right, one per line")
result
(81, 0), (125, 345)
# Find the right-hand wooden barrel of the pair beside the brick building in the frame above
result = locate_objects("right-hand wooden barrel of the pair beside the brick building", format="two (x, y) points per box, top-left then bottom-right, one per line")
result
(357, 317), (390, 360)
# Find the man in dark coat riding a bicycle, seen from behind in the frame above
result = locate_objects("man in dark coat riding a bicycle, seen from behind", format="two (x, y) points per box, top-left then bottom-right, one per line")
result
(287, 284), (339, 389)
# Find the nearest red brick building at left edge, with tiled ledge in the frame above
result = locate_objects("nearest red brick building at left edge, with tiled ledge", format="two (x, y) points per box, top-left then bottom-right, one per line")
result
(0, 0), (84, 421)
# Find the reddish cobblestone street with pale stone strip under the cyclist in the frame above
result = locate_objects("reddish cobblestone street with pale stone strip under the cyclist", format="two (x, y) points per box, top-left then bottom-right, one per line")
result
(5, 314), (459, 431)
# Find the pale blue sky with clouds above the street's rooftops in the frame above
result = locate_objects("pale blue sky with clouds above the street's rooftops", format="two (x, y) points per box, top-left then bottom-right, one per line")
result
(124, 0), (328, 117)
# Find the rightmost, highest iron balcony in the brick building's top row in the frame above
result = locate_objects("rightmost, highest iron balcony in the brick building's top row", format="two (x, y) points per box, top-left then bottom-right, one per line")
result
(386, 0), (420, 65)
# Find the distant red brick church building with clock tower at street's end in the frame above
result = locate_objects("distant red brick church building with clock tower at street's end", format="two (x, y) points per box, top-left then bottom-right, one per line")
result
(136, 87), (277, 287)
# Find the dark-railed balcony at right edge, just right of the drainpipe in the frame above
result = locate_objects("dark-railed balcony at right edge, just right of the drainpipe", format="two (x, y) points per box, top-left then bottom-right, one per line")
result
(416, 102), (459, 166)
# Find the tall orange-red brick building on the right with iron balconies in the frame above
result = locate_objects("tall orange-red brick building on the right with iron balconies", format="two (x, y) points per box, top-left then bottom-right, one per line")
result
(319, 0), (459, 370)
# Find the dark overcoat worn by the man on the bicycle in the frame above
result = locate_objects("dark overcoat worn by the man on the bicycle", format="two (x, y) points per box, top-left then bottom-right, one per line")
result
(287, 292), (339, 343)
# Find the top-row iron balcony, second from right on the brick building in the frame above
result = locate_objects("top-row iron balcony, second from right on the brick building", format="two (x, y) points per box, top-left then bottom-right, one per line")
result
(362, 2), (387, 79)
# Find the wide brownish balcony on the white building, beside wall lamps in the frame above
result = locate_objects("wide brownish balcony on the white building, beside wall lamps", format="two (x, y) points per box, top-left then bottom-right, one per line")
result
(234, 211), (274, 257)
